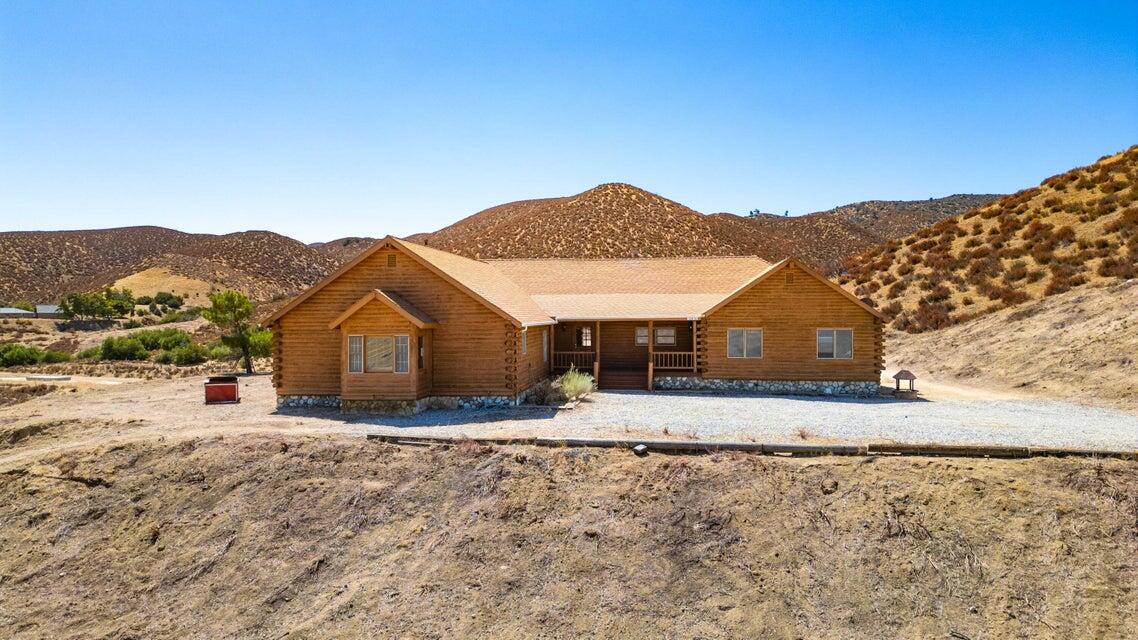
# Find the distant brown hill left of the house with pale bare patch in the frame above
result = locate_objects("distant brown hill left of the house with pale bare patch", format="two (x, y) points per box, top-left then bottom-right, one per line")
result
(0, 227), (339, 301)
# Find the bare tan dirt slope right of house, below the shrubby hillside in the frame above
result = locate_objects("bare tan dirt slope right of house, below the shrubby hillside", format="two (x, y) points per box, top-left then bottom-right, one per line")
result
(885, 280), (1138, 410)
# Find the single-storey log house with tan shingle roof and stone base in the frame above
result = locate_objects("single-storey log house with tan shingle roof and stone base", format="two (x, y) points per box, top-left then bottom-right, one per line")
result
(263, 237), (883, 412)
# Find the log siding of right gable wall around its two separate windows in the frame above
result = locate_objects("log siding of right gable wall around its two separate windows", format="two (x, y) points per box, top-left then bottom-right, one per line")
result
(700, 260), (883, 380)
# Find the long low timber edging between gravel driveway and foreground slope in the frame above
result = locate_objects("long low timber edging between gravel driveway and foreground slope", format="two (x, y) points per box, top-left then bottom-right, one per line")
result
(366, 434), (1138, 460)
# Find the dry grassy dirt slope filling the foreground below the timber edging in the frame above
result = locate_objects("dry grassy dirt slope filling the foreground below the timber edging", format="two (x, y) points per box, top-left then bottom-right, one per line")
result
(0, 424), (1138, 639)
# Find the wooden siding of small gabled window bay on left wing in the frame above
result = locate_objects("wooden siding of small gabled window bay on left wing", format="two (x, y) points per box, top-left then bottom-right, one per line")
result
(340, 302), (419, 400)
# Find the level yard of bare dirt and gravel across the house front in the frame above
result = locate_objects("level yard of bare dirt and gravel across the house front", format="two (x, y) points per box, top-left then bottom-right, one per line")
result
(0, 376), (1138, 462)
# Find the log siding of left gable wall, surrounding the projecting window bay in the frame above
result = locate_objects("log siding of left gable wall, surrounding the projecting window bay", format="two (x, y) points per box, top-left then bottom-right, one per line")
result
(273, 248), (512, 395)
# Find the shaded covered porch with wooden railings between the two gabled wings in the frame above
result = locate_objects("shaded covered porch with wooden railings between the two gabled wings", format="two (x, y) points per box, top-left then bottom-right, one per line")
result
(550, 319), (699, 389)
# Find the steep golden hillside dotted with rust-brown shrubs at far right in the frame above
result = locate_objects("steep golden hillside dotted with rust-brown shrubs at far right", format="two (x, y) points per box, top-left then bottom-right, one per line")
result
(841, 146), (1138, 333)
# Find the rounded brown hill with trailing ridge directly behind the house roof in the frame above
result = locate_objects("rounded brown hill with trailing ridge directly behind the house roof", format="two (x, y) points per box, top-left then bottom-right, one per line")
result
(410, 183), (996, 271)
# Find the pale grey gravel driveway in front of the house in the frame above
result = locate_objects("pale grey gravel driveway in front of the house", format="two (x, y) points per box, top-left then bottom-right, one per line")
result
(350, 392), (1138, 450)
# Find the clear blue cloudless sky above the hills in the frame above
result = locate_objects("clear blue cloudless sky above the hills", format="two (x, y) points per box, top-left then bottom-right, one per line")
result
(0, 0), (1138, 241)
